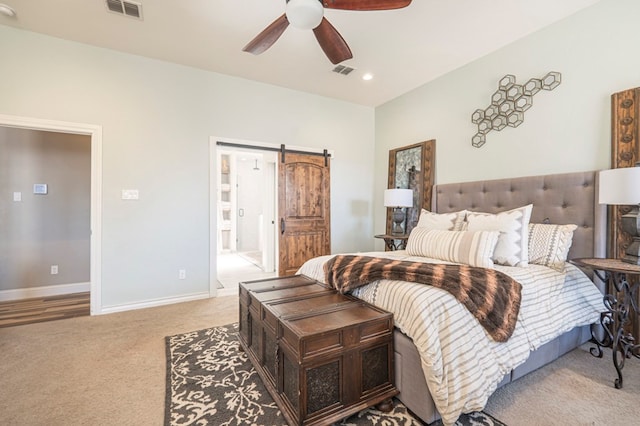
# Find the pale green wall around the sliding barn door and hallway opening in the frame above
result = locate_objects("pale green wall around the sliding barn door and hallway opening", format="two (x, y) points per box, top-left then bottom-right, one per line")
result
(0, 26), (374, 308)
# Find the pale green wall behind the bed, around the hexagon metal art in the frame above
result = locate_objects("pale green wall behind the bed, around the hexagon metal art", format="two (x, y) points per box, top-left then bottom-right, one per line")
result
(374, 0), (640, 248)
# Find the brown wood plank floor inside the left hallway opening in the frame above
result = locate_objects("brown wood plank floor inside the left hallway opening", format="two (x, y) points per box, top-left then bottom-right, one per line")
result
(0, 292), (91, 328)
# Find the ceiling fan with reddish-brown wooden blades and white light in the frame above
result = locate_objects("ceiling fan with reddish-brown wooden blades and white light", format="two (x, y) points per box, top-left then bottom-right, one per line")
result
(242, 0), (411, 64)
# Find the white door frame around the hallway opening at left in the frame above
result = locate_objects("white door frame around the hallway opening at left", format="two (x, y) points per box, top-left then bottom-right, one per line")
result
(0, 114), (102, 315)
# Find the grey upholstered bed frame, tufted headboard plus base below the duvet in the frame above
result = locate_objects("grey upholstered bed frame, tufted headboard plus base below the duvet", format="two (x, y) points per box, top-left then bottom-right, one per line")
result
(394, 171), (607, 423)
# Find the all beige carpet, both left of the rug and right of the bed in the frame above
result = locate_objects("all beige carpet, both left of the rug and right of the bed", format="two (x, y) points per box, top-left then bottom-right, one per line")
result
(0, 296), (640, 426)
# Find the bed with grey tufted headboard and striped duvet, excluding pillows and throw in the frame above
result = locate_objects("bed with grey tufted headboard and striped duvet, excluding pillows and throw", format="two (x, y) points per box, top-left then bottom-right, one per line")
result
(299, 172), (606, 424)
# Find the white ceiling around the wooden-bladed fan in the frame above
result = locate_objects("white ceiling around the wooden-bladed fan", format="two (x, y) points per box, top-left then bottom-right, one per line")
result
(0, 0), (599, 106)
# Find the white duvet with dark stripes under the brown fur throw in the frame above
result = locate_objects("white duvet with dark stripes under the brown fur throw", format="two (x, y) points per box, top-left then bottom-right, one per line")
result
(298, 251), (603, 425)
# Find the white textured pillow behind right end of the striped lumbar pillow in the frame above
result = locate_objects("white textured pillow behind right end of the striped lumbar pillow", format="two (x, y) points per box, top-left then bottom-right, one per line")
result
(467, 204), (533, 266)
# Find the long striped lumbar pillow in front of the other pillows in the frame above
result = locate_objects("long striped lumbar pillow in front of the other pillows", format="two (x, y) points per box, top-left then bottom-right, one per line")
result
(407, 228), (500, 268)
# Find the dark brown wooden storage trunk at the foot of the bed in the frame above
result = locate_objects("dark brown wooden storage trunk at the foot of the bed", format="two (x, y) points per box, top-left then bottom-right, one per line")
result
(239, 275), (398, 425)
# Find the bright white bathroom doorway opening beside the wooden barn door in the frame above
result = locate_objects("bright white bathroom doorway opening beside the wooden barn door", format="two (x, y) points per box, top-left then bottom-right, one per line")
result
(212, 146), (278, 296)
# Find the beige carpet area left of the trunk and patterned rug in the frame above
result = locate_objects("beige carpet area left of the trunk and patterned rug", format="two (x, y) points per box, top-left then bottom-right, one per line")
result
(0, 297), (238, 426)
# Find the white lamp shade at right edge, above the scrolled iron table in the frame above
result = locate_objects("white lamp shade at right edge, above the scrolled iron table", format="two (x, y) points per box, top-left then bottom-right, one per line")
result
(598, 167), (640, 205)
